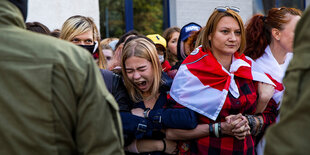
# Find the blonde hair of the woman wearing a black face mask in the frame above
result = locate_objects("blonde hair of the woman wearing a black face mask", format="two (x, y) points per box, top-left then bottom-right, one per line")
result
(60, 15), (106, 69)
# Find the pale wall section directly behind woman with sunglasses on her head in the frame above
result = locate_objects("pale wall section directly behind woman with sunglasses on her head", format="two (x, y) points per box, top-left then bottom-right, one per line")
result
(170, 0), (253, 28)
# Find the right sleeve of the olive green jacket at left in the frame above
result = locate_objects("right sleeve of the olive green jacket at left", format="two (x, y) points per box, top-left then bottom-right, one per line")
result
(76, 56), (123, 155)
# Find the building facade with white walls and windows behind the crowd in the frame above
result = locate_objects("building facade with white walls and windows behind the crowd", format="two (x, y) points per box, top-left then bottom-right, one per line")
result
(27, 0), (310, 38)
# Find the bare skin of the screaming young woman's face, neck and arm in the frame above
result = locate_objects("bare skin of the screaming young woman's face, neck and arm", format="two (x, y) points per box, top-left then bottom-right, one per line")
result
(125, 56), (177, 154)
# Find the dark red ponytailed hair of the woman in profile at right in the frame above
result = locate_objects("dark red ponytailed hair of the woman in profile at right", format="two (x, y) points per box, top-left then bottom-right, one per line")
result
(244, 7), (301, 60)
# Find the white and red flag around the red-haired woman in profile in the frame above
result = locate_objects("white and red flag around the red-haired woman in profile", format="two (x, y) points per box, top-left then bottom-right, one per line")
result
(255, 46), (293, 105)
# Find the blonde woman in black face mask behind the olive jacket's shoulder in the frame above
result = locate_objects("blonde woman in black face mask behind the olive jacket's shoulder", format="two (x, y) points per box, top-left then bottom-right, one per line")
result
(60, 15), (106, 69)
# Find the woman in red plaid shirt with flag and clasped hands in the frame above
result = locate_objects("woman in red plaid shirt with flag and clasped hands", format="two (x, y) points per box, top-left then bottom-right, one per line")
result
(166, 7), (277, 154)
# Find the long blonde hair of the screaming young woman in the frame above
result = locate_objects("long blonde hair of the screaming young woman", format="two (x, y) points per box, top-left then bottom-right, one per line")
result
(121, 38), (161, 102)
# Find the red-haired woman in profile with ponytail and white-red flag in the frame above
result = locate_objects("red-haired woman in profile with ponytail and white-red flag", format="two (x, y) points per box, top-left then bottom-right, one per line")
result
(245, 7), (301, 154)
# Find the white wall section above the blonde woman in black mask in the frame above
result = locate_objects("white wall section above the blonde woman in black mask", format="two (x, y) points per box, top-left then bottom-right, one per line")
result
(27, 0), (100, 31)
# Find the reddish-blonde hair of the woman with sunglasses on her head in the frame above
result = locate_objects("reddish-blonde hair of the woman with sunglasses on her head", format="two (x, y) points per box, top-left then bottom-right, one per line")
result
(202, 9), (246, 54)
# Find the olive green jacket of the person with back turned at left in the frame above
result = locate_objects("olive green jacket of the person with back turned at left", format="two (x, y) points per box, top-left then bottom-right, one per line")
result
(0, 0), (124, 155)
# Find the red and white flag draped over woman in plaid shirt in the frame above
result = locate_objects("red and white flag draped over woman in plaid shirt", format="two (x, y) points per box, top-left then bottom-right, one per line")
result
(170, 47), (273, 120)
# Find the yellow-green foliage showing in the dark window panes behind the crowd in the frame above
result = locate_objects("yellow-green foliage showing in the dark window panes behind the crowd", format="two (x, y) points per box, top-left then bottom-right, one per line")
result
(99, 0), (163, 38)
